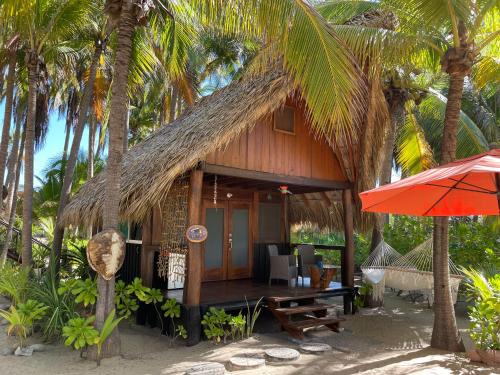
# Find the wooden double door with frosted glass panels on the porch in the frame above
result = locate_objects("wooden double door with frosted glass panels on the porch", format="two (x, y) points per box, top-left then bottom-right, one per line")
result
(202, 200), (252, 281)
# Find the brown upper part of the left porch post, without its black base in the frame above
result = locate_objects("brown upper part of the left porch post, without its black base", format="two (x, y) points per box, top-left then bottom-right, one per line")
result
(183, 170), (203, 306)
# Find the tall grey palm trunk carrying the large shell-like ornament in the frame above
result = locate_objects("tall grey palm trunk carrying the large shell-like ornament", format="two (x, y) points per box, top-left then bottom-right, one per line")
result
(89, 0), (137, 358)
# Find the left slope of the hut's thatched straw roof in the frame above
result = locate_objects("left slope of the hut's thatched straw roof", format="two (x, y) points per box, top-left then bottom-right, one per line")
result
(61, 69), (293, 225)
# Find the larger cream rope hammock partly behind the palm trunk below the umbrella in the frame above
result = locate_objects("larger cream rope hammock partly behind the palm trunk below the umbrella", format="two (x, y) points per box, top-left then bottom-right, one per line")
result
(385, 237), (463, 305)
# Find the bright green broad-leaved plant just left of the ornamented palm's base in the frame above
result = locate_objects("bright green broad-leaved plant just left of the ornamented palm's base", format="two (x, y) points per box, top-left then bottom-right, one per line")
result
(63, 316), (99, 356)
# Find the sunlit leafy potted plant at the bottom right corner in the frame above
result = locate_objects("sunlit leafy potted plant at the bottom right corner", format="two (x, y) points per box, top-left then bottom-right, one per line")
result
(462, 269), (500, 365)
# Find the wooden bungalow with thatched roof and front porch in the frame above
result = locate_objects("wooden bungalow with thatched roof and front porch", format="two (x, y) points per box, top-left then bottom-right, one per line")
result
(62, 69), (386, 344)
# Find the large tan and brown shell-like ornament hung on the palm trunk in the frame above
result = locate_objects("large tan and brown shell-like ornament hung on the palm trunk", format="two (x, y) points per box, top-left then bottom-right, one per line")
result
(87, 229), (125, 280)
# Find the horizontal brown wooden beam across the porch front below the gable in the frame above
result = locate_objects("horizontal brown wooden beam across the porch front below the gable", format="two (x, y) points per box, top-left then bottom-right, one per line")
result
(201, 163), (351, 190)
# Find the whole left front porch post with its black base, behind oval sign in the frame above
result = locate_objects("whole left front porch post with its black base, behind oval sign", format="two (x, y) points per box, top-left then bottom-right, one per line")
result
(183, 170), (203, 346)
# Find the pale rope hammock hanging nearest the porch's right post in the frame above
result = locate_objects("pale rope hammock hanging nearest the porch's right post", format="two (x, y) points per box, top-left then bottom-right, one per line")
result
(361, 240), (401, 301)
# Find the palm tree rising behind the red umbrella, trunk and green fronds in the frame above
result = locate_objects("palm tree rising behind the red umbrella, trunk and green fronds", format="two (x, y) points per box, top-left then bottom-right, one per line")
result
(322, 0), (500, 351)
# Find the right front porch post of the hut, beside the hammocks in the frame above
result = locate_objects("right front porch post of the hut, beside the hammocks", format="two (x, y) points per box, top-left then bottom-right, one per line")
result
(341, 189), (354, 314)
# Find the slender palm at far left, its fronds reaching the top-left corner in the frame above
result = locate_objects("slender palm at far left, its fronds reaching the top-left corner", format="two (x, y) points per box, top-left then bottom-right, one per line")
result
(2, 0), (90, 267)
